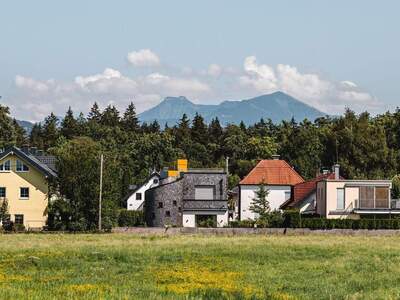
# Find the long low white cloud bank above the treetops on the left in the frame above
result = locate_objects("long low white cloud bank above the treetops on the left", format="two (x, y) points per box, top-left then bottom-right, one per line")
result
(7, 68), (210, 121)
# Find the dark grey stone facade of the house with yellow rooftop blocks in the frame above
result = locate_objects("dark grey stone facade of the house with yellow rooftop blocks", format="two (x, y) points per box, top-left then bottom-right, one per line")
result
(144, 172), (228, 227)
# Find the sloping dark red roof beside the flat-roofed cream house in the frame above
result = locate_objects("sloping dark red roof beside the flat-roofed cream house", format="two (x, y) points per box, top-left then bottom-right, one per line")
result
(280, 173), (343, 209)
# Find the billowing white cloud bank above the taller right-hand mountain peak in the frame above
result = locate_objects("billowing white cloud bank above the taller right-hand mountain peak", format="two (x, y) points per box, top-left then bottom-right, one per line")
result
(239, 56), (378, 113)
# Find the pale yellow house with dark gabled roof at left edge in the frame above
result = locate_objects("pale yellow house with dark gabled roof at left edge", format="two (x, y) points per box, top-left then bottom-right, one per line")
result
(0, 147), (57, 229)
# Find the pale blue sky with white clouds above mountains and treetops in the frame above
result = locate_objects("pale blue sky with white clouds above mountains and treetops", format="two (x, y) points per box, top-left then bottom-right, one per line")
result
(0, 0), (400, 121)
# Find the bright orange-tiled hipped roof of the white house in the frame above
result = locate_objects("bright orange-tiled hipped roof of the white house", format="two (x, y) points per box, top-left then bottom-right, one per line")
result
(239, 159), (304, 185)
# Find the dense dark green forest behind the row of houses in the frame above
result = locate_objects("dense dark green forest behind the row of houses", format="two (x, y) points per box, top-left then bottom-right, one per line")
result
(0, 103), (400, 229)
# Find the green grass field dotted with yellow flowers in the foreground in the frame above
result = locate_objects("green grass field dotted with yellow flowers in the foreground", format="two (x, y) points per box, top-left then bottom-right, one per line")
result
(0, 234), (400, 299)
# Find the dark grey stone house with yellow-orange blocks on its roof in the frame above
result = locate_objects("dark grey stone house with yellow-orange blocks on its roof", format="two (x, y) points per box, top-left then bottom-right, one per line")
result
(144, 160), (228, 227)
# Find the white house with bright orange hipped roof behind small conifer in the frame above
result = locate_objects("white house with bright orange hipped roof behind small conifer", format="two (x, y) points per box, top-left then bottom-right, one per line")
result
(238, 155), (304, 220)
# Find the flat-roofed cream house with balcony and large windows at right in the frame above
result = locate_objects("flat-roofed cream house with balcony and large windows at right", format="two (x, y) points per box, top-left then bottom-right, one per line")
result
(315, 169), (394, 219)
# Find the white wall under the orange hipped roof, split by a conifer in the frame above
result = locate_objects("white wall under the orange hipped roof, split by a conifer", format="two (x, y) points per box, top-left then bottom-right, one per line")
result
(240, 185), (291, 220)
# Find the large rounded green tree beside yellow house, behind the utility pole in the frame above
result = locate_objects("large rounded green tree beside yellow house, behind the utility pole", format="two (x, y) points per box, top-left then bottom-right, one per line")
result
(50, 137), (121, 230)
